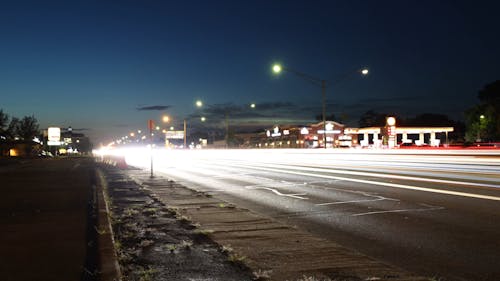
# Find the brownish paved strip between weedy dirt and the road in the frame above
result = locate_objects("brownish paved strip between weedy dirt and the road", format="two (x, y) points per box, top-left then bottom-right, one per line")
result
(123, 165), (429, 281)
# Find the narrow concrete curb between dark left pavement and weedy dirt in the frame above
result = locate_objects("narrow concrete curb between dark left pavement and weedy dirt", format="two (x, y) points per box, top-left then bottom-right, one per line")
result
(96, 169), (122, 281)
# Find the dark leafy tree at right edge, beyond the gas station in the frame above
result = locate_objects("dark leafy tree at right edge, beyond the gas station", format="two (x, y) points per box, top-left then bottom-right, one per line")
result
(465, 80), (500, 142)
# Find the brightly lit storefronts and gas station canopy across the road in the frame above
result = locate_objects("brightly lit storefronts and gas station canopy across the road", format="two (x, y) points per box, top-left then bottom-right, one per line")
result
(237, 118), (453, 148)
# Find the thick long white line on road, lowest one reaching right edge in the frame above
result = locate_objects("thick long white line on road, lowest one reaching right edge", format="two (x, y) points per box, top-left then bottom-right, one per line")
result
(233, 164), (500, 201)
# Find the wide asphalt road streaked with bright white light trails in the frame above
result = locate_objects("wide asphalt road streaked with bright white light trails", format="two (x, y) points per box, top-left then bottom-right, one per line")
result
(127, 150), (500, 280)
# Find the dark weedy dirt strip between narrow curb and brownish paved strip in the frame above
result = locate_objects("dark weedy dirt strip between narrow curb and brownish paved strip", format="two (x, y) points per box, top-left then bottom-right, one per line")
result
(104, 167), (254, 281)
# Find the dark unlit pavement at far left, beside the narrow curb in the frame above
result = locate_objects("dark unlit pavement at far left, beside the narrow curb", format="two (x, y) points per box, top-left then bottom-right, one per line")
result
(0, 158), (95, 281)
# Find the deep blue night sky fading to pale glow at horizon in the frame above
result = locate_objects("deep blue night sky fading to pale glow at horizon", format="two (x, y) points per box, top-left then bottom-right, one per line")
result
(0, 0), (500, 143)
